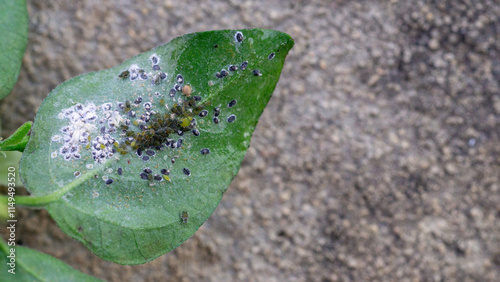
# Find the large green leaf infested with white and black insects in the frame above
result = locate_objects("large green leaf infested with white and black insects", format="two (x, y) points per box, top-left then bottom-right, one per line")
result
(17, 29), (293, 264)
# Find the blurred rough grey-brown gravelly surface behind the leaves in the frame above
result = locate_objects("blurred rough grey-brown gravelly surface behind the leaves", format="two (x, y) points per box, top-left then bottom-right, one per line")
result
(0, 0), (500, 281)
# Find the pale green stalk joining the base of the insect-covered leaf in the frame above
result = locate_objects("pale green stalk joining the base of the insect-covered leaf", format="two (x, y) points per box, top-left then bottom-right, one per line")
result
(0, 164), (102, 208)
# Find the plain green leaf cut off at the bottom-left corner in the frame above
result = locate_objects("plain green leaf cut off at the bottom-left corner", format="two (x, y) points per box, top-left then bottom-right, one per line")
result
(0, 240), (102, 282)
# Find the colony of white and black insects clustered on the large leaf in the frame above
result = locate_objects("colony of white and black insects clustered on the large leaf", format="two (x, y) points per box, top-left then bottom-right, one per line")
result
(51, 32), (256, 185)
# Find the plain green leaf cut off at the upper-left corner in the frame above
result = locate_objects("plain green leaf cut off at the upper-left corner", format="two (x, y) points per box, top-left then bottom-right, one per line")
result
(0, 0), (28, 100)
